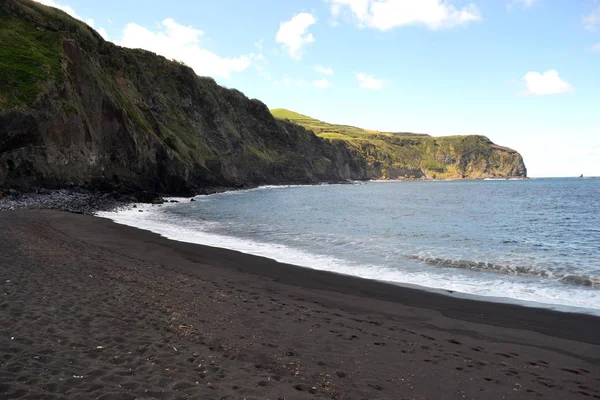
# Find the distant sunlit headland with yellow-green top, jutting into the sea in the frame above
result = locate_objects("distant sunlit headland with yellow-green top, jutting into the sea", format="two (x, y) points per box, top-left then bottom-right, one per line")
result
(271, 108), (527, 179)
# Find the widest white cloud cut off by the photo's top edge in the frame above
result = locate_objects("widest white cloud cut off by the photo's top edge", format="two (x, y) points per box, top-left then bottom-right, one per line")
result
(328, 0), (481, 31)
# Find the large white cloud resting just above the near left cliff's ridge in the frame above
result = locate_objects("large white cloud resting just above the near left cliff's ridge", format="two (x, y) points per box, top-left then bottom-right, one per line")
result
(117, 18), (254, 79)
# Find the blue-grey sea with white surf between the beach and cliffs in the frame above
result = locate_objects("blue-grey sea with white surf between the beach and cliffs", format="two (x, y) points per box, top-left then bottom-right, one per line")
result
(99, 178), (600, 315)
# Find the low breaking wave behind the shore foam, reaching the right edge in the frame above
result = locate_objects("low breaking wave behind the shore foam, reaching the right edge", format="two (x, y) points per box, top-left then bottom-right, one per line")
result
(409, 256), (600, 288)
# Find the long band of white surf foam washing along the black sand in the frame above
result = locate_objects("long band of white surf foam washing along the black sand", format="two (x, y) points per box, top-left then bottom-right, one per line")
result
(97, 203), (600, 315)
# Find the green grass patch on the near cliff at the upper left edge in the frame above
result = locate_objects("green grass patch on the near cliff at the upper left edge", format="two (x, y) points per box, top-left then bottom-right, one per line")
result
(0, 10), (63, 109)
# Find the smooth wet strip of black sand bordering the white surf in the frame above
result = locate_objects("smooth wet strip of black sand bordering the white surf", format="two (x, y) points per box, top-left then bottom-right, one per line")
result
(95, 211), (600, 345)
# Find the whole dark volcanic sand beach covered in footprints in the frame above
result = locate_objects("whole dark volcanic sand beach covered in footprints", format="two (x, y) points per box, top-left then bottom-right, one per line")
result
(0, 210), (600, 399)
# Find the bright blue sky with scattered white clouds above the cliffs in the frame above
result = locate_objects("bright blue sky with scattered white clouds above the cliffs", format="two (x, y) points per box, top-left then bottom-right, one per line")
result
(38, 0), (600, 177)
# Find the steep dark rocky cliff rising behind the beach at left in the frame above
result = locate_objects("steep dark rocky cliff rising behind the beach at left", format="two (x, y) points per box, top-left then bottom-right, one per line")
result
(0, 0), (522, 194)
